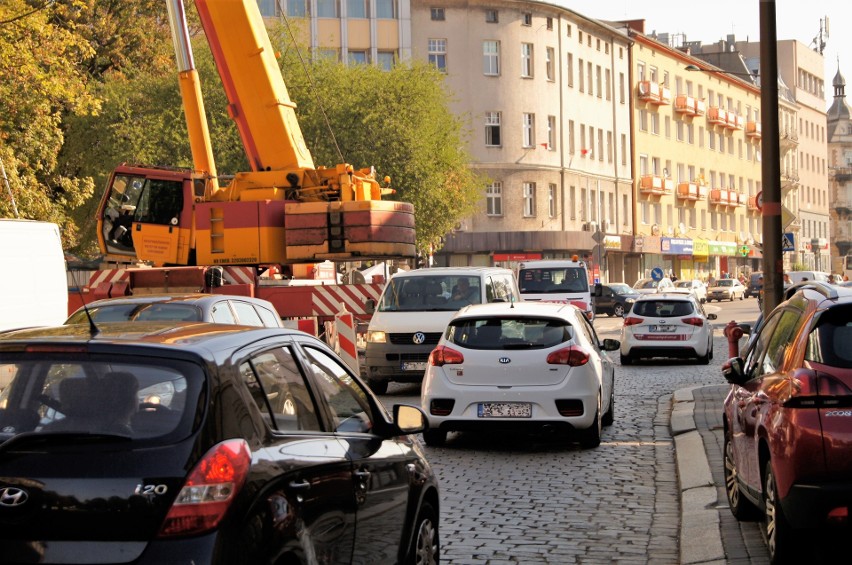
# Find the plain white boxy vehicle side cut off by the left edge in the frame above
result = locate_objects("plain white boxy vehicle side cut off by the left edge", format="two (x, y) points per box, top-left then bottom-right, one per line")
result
(0, 219), (68, 331)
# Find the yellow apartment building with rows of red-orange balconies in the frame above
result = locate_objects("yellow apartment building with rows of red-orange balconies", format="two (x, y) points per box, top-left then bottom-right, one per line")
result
(625, 27), (762, 279)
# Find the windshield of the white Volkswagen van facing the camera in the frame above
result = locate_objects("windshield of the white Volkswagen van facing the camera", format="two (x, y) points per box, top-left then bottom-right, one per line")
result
(378, 275), (482, 312)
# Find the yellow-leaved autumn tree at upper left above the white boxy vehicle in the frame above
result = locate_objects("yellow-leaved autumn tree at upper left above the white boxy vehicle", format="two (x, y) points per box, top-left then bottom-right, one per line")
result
(0, 0), (98, 246)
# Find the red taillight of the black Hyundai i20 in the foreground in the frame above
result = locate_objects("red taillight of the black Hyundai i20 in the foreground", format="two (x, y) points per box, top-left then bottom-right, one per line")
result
(159, 439), (251, 537)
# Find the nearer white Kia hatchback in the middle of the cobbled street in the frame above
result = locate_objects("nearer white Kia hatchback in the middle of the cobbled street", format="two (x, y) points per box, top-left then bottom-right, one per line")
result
(421, 302), (619, 448)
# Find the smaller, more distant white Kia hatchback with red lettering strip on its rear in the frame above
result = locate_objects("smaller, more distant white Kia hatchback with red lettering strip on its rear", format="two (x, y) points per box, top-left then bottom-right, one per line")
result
(621, 292), (716, 365)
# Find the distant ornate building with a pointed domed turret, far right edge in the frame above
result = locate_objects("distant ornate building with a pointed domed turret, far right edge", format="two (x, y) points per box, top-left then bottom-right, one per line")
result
(824, 68), (852, 275)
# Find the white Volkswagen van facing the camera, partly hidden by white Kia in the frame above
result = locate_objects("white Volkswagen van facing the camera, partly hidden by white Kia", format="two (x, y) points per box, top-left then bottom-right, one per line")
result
(364, 267), (520, 394)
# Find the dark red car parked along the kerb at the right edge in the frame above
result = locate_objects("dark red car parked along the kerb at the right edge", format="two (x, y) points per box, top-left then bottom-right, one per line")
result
(723, 282), (852, 563)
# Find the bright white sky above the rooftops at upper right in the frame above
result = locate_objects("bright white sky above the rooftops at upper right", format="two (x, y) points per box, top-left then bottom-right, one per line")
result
(564, 0), (852, 106)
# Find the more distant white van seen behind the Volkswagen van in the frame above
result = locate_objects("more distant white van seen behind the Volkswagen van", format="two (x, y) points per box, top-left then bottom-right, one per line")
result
(518, 256), (595, 320)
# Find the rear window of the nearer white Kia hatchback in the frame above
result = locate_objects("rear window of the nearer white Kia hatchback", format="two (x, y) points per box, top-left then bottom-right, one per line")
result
(447, 318), (573, 349)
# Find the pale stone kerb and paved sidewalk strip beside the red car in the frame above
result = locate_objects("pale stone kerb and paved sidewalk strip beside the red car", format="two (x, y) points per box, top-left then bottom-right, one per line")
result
(671, 385), (769, 565)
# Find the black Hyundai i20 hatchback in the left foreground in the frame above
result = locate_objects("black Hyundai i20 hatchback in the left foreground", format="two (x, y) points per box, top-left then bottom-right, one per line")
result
(0, 322), (439, 565)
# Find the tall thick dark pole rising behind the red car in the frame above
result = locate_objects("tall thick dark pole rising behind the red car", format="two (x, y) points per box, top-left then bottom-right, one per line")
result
(760, 0), (784, 316)
